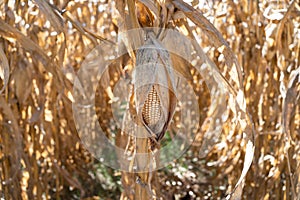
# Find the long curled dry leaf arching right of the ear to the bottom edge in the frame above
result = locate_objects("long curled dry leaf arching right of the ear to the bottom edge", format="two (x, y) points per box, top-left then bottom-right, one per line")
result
(174, 0), (255, 199)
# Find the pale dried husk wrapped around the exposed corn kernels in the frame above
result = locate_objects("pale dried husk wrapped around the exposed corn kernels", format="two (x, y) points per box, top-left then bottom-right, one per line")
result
(133, 32), (177, 148)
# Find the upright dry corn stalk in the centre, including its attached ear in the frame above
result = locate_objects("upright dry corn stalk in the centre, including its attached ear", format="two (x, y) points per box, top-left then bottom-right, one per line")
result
(117, 0), (176, 199)
